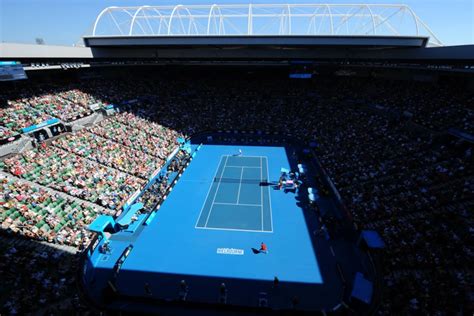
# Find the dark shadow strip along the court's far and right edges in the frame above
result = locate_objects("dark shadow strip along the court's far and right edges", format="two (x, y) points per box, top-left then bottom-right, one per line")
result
(189, 131), (370, 305)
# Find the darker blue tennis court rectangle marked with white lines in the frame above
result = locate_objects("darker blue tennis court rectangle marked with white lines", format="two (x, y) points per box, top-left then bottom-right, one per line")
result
(195, 155), (273, 232)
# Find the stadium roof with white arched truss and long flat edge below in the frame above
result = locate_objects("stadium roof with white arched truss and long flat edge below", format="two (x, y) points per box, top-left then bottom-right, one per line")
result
(0, 4), (474, 70)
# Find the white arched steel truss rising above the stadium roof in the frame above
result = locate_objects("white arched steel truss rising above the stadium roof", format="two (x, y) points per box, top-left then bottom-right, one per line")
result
(91, 4), (443, 46)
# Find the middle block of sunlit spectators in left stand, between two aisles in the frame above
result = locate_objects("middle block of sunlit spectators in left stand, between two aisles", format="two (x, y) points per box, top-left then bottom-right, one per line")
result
(3, 146), (144, 209)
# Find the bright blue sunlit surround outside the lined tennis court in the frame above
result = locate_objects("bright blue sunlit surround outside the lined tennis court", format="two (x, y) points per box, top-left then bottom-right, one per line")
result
(100, 145), (323, 286)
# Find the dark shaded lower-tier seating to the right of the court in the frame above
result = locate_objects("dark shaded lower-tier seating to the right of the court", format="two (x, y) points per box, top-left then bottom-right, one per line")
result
(315, 107), (474, 314)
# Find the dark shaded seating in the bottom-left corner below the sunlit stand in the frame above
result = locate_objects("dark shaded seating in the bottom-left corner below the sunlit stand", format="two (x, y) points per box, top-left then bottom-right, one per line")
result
(0, 237), (84, 315)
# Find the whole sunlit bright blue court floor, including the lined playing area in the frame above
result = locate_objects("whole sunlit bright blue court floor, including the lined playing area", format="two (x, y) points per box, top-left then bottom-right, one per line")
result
(122, 145), (322, 283)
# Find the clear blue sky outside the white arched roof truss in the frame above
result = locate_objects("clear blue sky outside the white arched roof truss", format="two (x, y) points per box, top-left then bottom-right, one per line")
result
(0, 0), (474, 46)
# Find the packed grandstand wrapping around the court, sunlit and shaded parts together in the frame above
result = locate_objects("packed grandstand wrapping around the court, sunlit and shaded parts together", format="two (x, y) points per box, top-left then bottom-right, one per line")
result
(0, 69), (474, 314)
